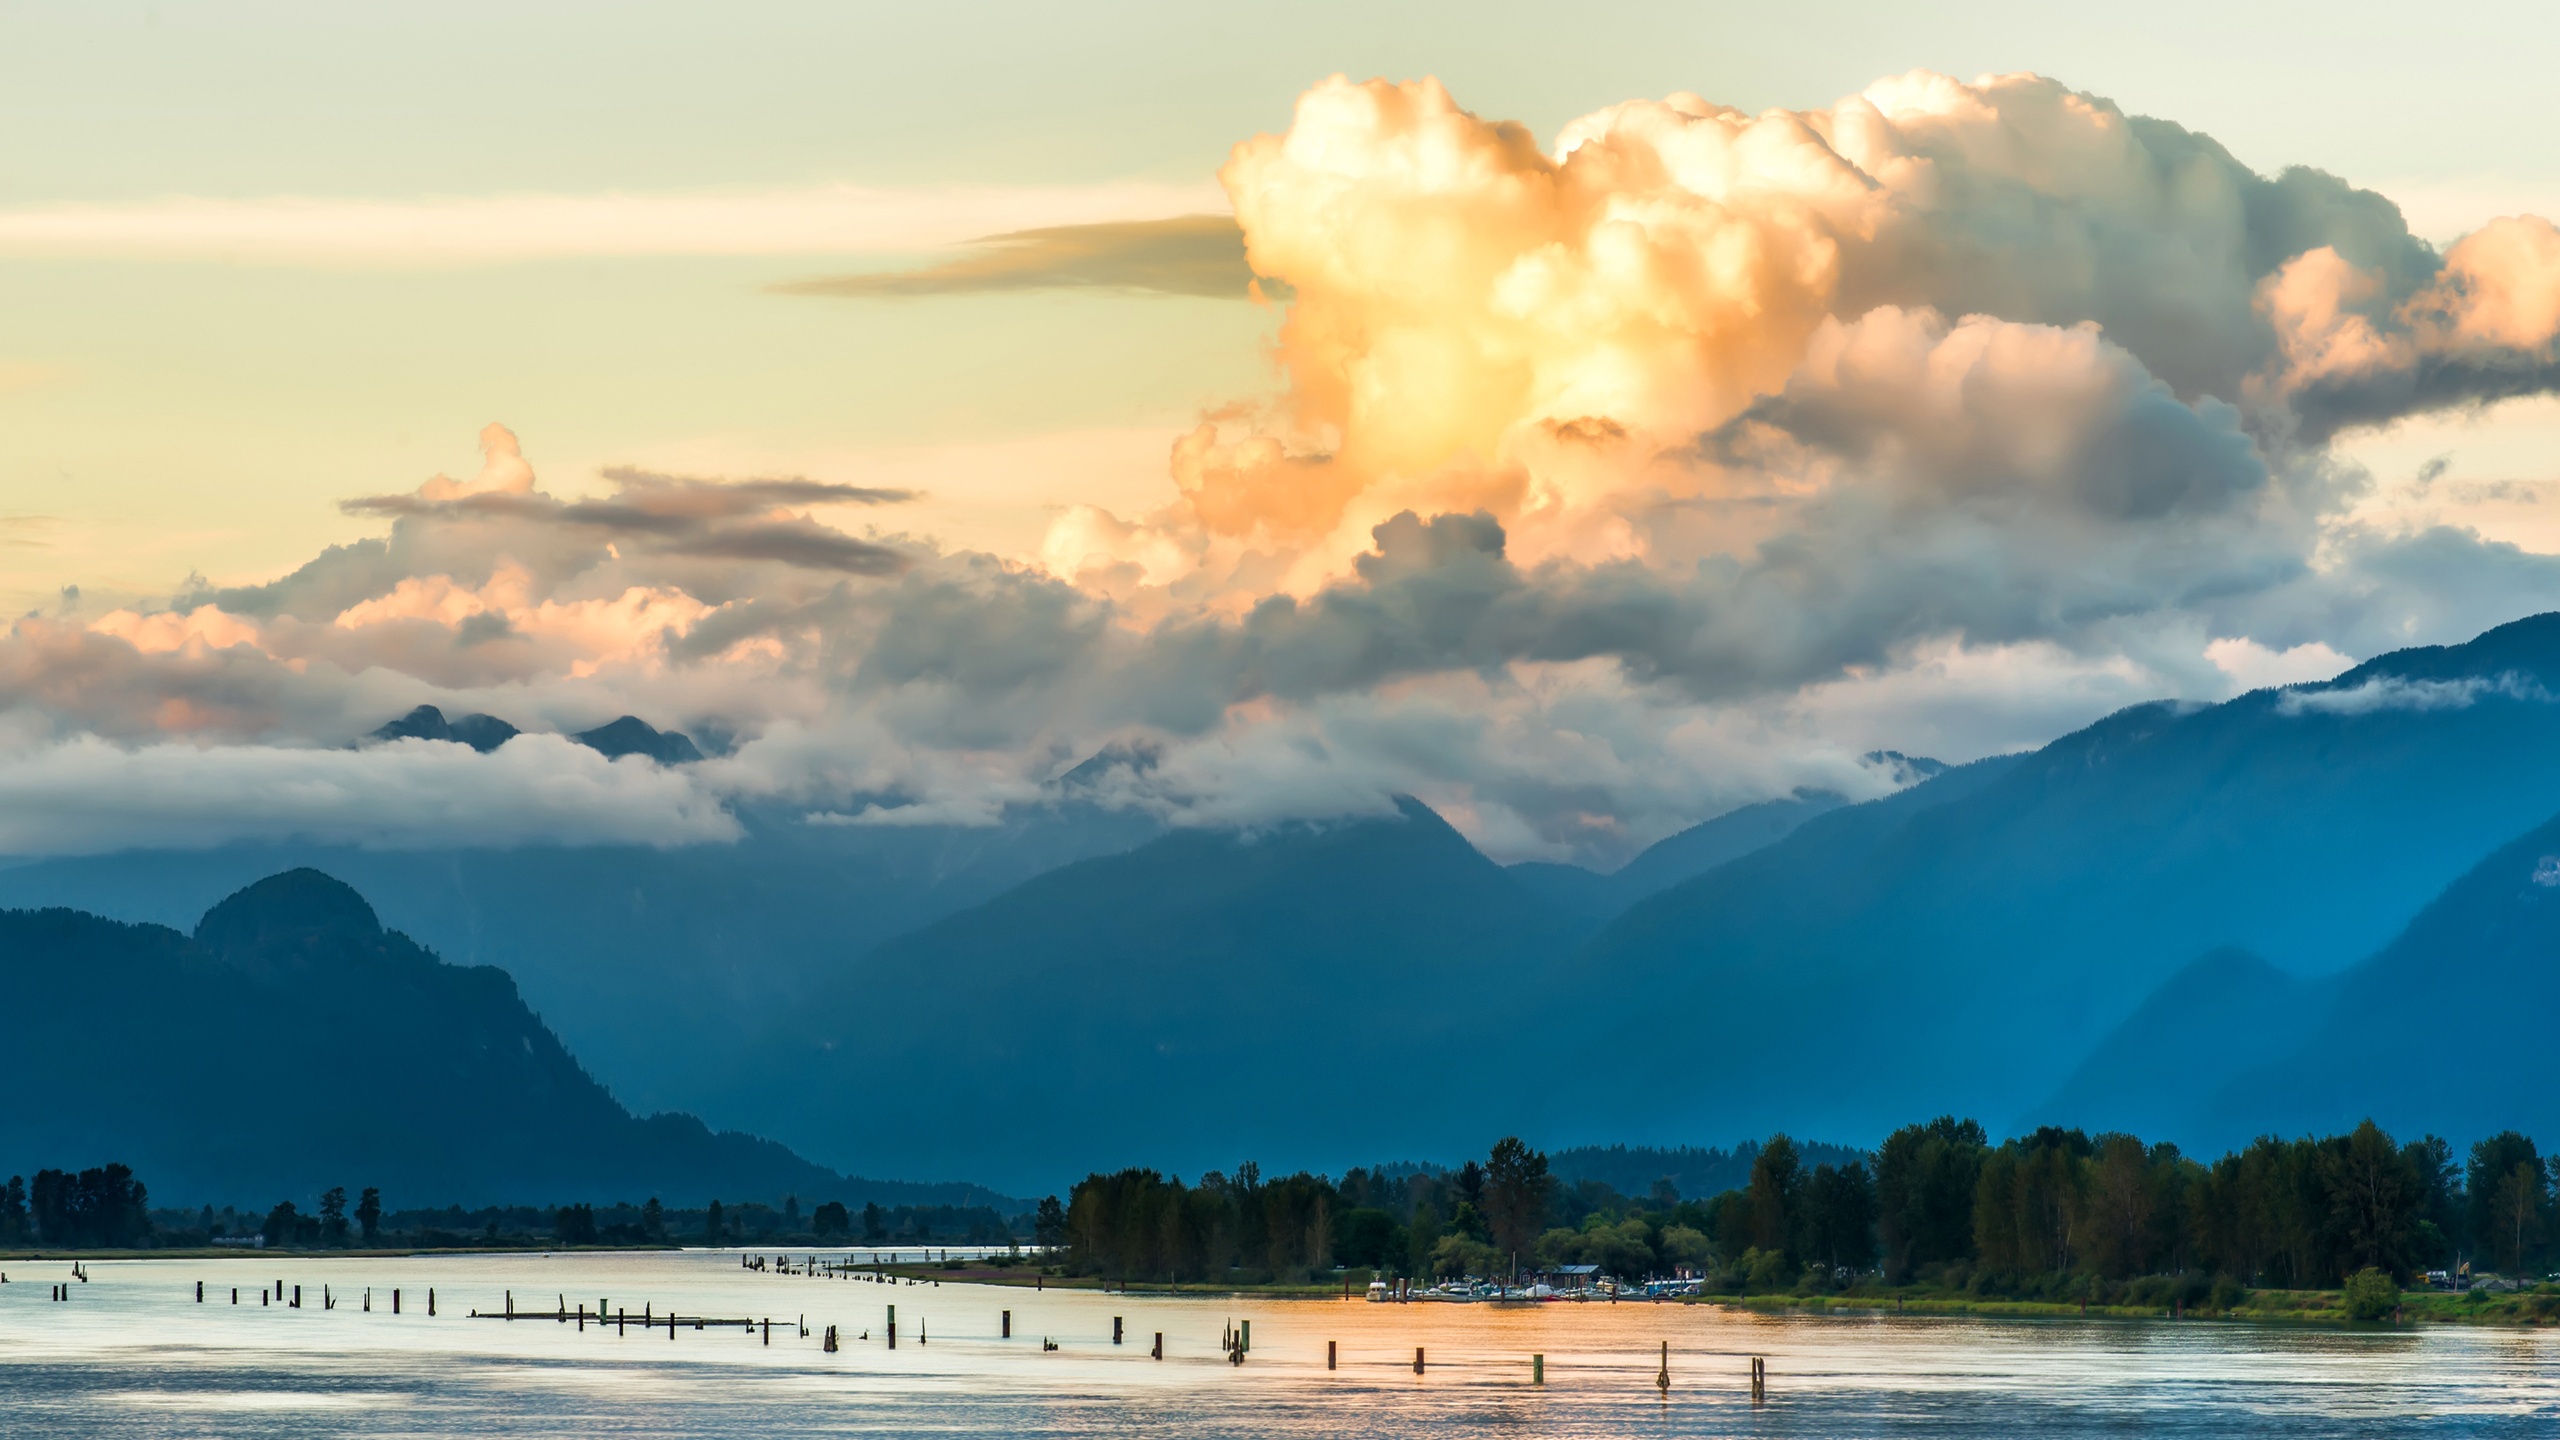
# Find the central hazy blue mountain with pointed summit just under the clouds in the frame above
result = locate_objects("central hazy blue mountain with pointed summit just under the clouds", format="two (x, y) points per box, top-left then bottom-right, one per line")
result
(735, 802), (1587, 1186)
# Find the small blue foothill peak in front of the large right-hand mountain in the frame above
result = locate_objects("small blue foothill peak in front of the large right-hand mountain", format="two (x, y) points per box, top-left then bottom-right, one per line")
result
(2030, 948), (2353, 1138)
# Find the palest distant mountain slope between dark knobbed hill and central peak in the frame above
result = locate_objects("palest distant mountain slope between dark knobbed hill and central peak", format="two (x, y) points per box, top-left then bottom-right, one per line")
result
(0, 802), (1157, 1125)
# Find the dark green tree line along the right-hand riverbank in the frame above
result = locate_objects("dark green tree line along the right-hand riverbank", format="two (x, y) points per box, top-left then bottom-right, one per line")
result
(1042, 1117), (2560, 1304)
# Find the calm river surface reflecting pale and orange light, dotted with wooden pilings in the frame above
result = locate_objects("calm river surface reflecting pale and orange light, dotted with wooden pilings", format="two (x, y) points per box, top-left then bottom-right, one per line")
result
(0, 1250), (2560, 1440)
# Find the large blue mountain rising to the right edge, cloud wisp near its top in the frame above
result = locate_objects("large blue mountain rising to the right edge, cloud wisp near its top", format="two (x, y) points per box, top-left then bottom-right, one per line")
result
(1569, 615), (2560, 1140)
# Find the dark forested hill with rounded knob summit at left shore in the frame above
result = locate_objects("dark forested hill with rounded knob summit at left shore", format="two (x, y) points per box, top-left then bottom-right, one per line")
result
(0, 869), (1018, 1204)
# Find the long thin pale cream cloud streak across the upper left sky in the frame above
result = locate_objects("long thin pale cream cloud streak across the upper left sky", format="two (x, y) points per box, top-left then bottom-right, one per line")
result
(0, 182), (1221, 266)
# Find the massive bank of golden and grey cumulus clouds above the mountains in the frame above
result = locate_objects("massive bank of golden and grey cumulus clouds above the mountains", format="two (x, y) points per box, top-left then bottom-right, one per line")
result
(15, 74), (2560, 861)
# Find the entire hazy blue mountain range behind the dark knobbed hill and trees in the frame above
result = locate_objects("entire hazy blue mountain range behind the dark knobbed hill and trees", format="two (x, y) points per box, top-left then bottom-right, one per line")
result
(15, 604), (2560, 1194)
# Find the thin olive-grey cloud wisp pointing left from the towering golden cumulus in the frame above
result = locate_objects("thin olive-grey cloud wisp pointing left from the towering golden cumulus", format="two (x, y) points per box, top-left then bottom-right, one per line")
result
(773, 215), (1254, 300)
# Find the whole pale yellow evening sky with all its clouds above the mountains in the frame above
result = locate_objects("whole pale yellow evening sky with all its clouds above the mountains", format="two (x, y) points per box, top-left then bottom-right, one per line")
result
(0, 3), (2560, 863)
